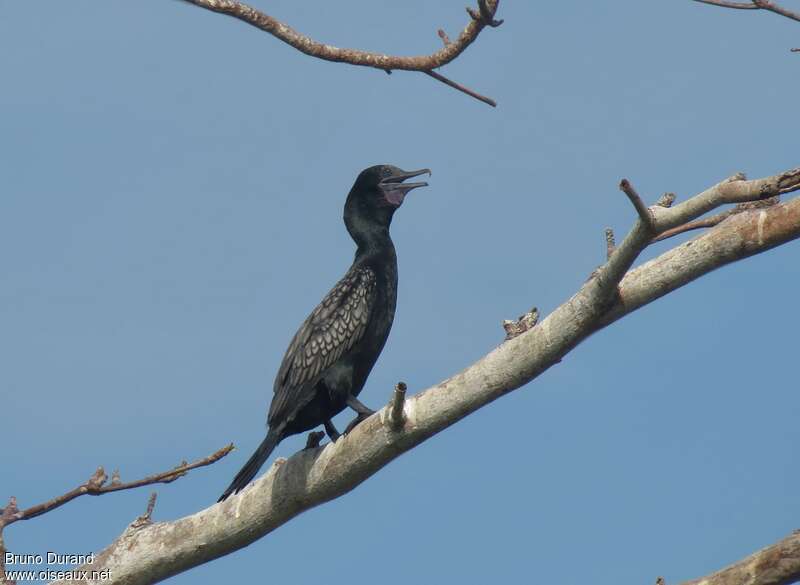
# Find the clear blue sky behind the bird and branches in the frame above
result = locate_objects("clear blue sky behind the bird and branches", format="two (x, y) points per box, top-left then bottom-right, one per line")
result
(0, 0), (800, 585)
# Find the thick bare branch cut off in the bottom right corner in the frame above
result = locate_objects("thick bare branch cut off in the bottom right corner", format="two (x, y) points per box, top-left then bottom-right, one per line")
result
(681, 530), (800, 585)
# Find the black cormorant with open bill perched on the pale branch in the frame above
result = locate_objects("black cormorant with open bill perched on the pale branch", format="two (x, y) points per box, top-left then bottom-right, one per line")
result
(219, 165), (430, 501)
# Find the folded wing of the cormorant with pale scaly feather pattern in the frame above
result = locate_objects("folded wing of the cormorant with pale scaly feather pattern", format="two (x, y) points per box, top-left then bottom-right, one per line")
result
(267, 266), (376, 426)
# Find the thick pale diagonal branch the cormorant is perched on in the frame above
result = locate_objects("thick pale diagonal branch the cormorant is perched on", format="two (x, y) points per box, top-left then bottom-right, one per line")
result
(50, 164), (800, 585)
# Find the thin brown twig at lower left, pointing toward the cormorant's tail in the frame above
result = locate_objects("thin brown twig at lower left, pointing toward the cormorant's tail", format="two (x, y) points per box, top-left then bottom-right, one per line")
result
(2, 444), (233, 526)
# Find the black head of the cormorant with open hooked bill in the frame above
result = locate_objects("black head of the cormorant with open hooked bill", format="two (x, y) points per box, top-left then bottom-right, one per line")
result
(344, 165), (431, 239)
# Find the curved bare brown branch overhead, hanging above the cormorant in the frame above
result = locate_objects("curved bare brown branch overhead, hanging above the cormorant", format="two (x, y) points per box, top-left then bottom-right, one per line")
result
(178, 0), (503, 107)
